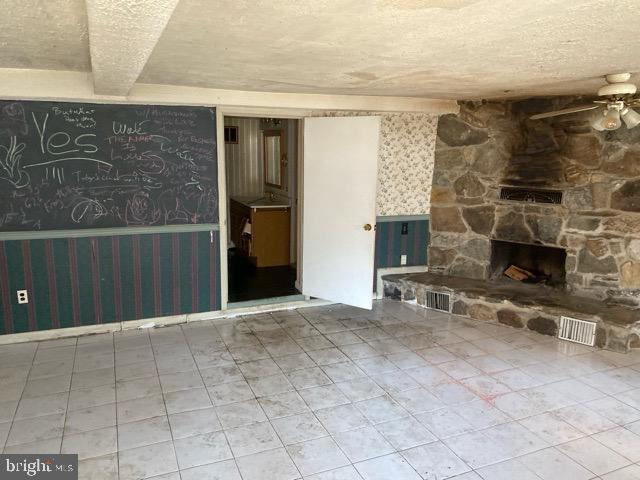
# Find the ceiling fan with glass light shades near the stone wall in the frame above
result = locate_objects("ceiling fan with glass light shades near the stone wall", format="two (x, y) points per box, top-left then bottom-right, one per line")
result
(530, 73), (640, 132)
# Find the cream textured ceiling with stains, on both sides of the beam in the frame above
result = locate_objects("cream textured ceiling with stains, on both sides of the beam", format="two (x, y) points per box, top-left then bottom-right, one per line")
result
(0, 0), (640, 99)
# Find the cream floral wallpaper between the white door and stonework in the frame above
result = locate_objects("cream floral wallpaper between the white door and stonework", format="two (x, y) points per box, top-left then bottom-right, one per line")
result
(321, 112), (438, 216)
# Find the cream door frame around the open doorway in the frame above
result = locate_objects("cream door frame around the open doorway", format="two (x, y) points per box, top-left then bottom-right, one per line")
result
(216, 106), (312, 311)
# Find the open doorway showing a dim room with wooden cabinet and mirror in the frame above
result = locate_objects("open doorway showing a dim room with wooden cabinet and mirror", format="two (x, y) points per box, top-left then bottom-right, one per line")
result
(224, 116), (300, 304)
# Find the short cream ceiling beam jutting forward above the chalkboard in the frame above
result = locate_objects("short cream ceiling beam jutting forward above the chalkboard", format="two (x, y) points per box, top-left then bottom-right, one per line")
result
(86, 0), (179, 96)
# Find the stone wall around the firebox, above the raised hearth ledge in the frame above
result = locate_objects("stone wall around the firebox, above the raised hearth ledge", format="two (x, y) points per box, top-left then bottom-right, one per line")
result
(428, 98), (640, 306)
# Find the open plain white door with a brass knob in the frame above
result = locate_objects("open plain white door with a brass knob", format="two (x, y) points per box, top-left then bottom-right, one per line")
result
(302, 117), (380, 309)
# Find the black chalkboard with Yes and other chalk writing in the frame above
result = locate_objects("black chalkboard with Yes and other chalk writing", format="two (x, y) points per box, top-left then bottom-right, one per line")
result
(0, 101), (218, 232)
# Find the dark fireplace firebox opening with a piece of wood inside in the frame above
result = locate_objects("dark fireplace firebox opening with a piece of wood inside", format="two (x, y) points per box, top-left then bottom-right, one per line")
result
(491, 240), (567, 288)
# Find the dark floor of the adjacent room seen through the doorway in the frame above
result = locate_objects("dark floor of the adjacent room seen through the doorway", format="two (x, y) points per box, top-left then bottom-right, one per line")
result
(229, 254), (300, 302)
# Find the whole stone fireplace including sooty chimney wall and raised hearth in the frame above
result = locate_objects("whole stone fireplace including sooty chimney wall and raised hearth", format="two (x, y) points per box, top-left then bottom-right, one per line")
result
(385, 98), (640, 351)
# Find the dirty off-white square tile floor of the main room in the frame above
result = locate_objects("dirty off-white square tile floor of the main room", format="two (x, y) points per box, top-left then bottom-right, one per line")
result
(0, 301), (640, 480)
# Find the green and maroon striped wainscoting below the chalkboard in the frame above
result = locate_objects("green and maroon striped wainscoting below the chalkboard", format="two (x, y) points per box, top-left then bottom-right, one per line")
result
(0, 231), (221, 334)
